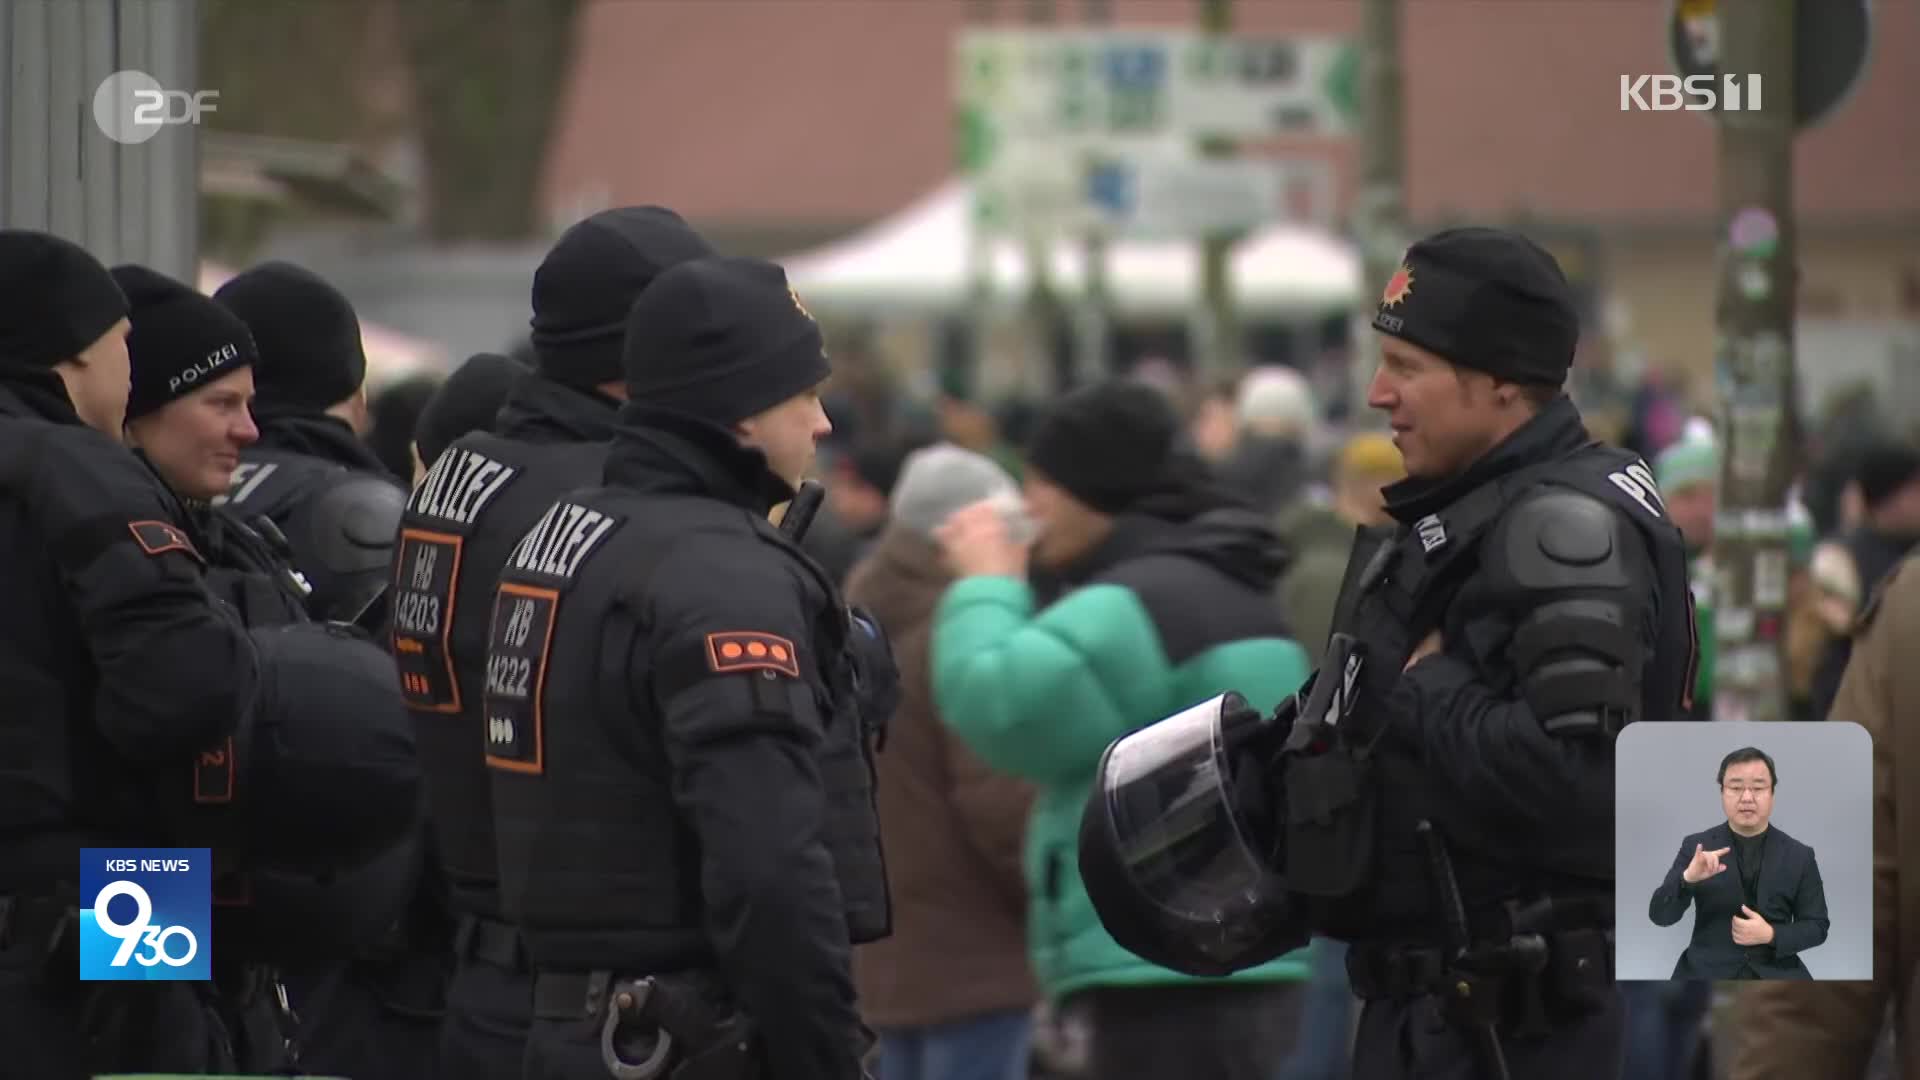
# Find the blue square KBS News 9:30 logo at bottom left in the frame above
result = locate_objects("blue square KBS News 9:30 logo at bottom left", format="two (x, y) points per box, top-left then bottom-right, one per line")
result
(81, 847), (213, 982)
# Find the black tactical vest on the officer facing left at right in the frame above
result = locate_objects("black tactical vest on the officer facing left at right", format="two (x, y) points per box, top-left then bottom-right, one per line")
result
(1315, 444), (1697, 940)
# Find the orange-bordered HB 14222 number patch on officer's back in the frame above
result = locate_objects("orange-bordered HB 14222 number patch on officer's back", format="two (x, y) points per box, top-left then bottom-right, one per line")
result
(484, 584), (561, 776)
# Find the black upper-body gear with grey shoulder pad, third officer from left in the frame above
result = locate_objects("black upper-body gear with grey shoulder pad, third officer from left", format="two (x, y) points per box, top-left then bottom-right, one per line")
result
(213, 448), (405, 626)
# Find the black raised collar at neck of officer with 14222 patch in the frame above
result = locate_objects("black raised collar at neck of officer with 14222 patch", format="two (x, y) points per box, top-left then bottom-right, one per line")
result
(607, 402), (793, 515)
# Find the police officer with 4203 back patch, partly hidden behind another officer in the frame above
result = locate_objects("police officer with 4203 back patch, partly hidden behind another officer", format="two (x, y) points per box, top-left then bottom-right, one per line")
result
(392, 206), (710, 1080)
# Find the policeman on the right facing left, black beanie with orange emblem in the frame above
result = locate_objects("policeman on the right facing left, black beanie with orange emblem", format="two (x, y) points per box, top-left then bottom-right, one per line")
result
(1083, 229), (1695, 1080)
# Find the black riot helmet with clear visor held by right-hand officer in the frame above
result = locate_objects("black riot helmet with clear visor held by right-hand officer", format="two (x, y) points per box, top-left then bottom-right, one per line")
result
(1079, 692), (1309, 976)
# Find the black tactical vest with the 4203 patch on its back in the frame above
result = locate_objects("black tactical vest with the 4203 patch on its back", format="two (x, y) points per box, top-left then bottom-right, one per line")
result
(390, 432), (607, 919)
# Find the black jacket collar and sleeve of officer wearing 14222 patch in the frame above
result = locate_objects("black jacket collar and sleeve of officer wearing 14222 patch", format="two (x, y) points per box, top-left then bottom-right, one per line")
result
(591, 405), (860, 1080)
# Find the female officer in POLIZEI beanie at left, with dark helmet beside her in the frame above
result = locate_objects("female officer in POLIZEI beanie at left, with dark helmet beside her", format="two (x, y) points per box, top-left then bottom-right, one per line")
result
(113, 265), (422, 1072)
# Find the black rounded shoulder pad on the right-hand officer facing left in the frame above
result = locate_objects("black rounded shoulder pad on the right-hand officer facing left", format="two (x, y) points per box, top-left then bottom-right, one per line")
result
(1482, 486), (1630, 588)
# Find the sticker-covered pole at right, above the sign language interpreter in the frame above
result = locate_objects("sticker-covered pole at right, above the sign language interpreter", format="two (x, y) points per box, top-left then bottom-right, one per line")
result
(1713, 0), (1797, 721)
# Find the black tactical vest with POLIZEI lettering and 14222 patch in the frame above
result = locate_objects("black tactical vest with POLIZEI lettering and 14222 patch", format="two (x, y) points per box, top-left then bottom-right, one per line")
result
(484, 488), (891, 972)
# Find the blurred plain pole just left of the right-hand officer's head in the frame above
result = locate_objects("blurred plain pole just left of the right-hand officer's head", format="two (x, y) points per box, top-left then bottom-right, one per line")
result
(1348, 0), (1409, 427)
